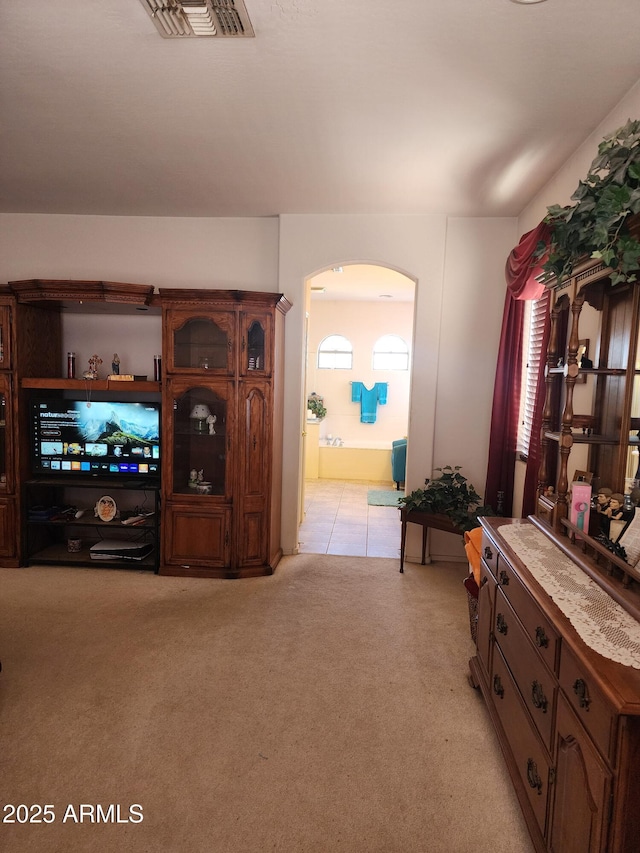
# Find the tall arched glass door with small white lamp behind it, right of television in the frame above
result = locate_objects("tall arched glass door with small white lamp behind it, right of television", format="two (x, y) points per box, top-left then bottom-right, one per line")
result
(169, 380), (232, 499)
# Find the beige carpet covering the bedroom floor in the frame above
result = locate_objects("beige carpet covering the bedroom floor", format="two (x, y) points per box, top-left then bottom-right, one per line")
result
(0, 554), (532, 853)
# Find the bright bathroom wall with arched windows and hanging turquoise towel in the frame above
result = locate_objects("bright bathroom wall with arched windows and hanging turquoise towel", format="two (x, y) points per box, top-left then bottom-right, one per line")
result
(307, 300), (413, 449)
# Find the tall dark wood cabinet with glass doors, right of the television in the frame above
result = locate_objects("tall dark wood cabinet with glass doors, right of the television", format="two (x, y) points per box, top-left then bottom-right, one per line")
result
(159, 289), (289, 577)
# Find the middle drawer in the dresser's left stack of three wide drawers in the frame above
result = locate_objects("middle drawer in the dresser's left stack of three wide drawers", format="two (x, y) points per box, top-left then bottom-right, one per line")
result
(494, 588), (558, 752)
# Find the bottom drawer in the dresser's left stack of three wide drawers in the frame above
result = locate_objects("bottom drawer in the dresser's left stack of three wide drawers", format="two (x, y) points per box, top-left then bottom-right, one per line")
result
(491, 646), (551, 835)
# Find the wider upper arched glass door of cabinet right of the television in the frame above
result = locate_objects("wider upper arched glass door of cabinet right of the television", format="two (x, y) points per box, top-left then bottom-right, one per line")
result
(168, 312), (235, 374)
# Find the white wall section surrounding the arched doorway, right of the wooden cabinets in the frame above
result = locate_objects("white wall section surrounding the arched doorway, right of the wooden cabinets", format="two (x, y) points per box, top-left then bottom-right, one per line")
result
(280, 215), (516, 558)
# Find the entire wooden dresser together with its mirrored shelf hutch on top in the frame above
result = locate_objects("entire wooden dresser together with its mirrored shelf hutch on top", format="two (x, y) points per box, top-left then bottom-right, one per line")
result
(470, 243), (640, 853)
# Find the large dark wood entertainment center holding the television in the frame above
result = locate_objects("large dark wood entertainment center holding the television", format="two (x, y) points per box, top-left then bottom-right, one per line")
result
(0, 279), (290, 578)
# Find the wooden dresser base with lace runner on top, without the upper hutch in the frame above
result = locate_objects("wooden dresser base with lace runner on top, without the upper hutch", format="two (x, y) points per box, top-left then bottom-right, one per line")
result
(470, 518), (640, 853)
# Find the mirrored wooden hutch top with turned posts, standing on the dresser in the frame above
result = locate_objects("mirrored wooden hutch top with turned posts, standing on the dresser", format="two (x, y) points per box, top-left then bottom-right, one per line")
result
(537, 260), (640, 531)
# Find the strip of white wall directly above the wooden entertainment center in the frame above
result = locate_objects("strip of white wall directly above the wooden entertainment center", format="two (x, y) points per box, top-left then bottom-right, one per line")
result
(0, 214), (278, 292)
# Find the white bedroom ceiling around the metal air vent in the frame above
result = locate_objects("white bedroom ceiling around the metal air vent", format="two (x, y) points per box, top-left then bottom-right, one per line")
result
(0, 0), (640, 223)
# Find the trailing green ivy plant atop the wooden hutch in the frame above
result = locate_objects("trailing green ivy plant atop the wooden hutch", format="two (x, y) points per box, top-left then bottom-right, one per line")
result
(537, 120), (640, 284)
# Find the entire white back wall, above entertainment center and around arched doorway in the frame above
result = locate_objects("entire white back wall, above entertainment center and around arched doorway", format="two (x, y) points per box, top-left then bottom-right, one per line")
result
(0, 209), (514, 557)
